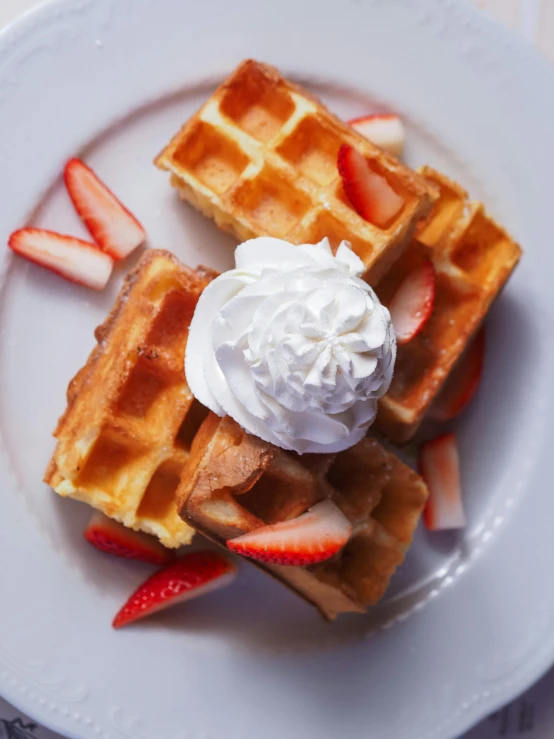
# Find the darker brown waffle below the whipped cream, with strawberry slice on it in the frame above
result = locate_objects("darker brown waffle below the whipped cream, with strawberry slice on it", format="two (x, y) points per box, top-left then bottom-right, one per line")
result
(177, 413), (427, 619)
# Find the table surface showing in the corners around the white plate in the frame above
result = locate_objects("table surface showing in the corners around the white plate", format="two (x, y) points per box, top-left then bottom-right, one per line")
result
(0, 0), (554, 739)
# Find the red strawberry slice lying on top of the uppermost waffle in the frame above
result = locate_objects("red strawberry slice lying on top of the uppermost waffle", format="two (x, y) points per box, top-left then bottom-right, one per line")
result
(337, 144), (404, 228)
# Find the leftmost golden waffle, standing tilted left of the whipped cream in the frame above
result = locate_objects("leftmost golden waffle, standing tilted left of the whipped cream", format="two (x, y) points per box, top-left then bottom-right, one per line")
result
(44, 250), (216, 548)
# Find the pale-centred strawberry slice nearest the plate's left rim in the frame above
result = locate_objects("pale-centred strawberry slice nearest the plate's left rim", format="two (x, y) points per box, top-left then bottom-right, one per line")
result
(8, 228), (113, 290)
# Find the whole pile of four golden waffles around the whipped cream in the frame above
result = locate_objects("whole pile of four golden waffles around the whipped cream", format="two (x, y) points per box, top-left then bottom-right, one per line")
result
(46, 61), (520, 618)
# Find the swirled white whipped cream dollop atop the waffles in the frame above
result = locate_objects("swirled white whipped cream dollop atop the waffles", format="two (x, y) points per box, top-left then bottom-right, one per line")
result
(185, 237), (396, 454)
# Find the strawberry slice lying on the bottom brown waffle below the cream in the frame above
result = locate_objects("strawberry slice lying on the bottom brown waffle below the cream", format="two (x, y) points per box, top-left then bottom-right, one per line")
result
(227, 500), (352, 567)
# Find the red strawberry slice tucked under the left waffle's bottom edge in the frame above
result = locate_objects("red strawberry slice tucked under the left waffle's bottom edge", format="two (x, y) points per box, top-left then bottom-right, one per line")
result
(85, 511), (175, 565)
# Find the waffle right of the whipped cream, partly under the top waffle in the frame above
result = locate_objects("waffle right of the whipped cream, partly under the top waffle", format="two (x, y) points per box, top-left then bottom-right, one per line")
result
(376, 167), (521, 443)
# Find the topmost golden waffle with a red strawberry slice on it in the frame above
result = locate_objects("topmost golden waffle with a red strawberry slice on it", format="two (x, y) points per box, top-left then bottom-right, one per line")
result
(156, 60), (437, 284)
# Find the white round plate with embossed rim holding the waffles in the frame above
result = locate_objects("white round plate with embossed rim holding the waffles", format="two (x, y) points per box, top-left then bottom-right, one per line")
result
(0, 0), (554, 739)
